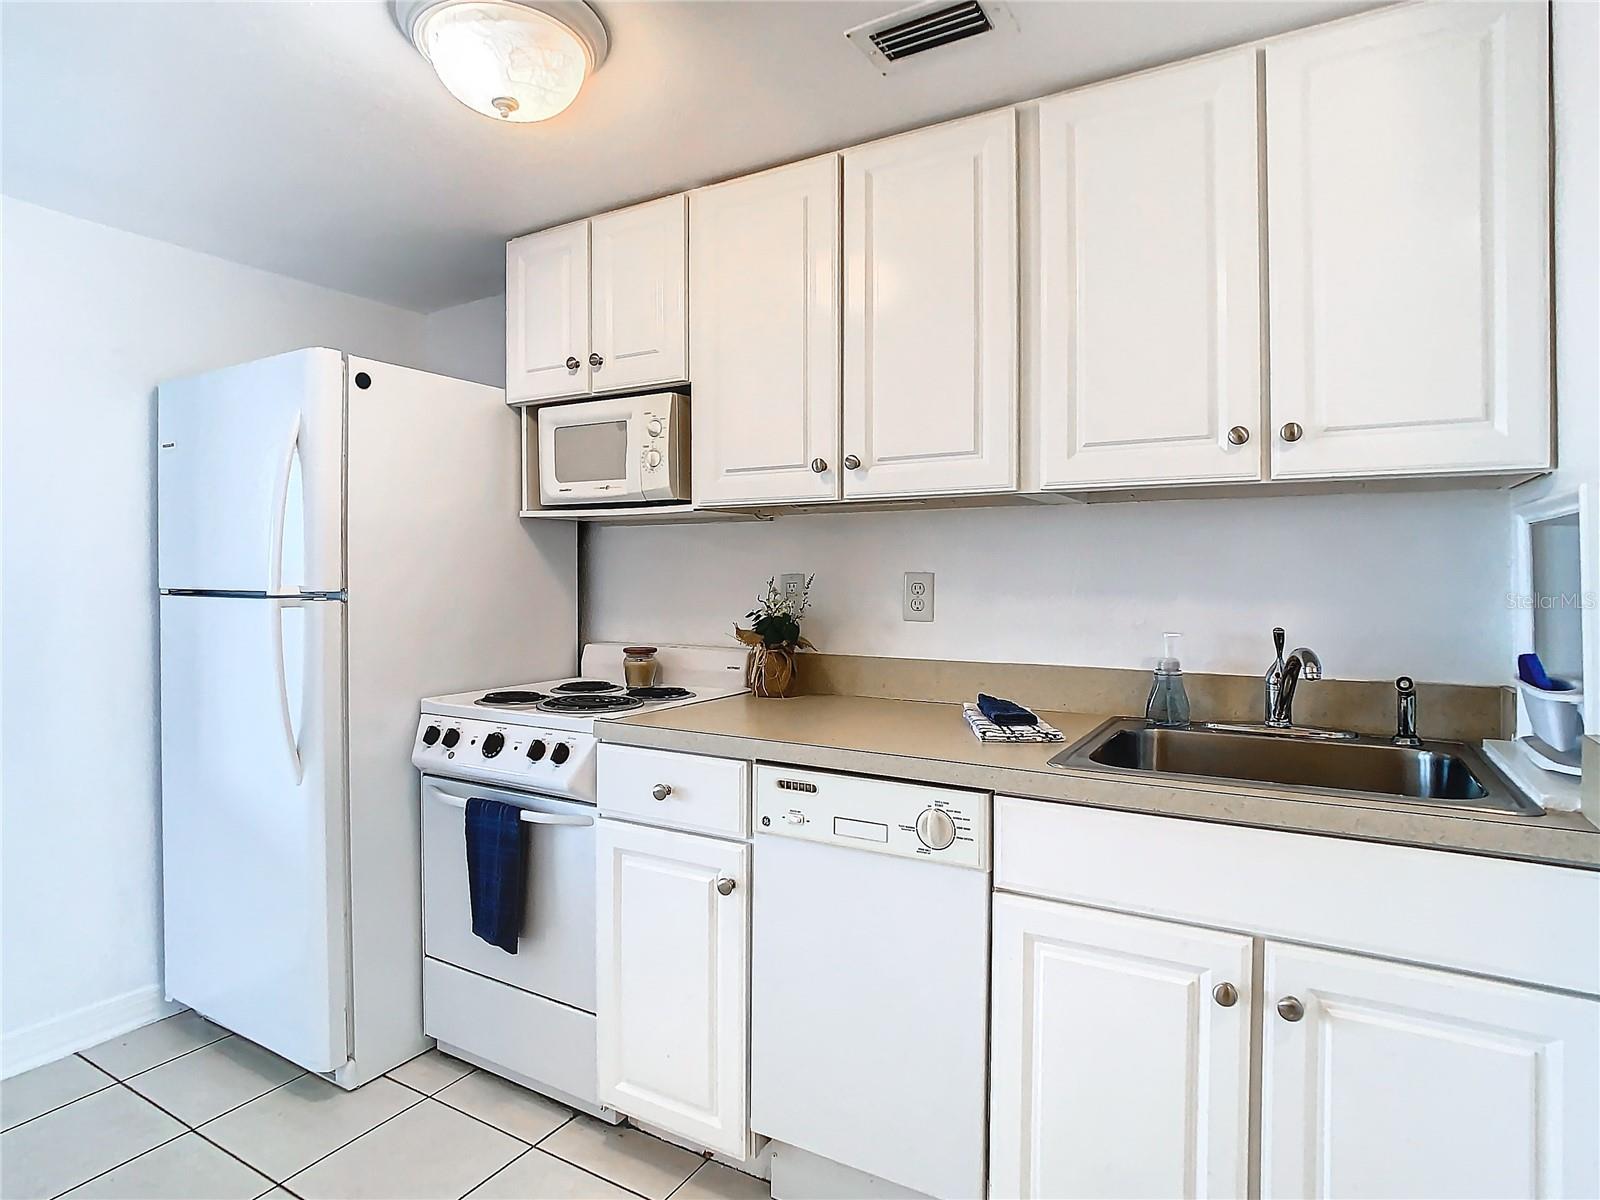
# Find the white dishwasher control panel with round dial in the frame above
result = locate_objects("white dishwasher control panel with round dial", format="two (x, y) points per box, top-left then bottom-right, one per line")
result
(755, 763), (992, 870)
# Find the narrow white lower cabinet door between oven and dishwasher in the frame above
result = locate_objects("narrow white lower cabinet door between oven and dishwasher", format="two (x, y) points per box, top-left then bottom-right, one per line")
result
(595, 819), (750, 1158)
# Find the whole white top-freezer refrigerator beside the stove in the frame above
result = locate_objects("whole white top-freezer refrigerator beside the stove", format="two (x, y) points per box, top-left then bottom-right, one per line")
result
(155, 349), (578, 1088)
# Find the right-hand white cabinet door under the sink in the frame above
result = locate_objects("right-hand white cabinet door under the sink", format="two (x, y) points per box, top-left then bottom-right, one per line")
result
(1261, 942), (1600, 1197)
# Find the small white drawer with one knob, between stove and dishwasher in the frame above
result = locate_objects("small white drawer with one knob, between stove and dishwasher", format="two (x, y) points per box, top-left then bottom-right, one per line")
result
(600, 746), (750, 837)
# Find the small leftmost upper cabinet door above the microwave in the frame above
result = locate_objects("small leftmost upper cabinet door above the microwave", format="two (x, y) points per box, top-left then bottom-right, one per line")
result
(506, 221), (589, 403)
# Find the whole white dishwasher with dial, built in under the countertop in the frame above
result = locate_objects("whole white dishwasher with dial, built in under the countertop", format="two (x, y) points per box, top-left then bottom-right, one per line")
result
(750, 765), (990, 1200)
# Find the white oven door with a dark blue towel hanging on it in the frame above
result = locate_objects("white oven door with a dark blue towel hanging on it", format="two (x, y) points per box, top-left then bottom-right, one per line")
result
(422, 776), (595, 1013)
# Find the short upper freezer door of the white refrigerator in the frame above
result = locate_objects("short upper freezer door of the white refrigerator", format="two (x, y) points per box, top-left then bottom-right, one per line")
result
(155, 349), (344, 595)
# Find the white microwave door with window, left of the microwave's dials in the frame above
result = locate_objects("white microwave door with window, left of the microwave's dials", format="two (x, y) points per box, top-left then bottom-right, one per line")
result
(536, 397), (645, 504)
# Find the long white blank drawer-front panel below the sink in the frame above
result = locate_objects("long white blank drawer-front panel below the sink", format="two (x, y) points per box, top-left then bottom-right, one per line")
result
(995, 795), (1600, 995)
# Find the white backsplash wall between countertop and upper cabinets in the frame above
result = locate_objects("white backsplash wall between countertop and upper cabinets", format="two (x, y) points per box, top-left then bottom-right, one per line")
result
(582, 491), (1512, 683)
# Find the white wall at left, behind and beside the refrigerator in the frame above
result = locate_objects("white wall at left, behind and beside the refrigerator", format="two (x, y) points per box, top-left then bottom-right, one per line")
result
(0, 198), (426, 1074)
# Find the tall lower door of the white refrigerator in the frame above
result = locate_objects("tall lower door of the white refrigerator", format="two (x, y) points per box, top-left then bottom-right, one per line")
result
(162, 595), (349, 1070)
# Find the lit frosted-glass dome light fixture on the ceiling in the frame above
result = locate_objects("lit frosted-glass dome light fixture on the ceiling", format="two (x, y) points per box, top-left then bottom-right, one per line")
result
(394, 0), (608, 122)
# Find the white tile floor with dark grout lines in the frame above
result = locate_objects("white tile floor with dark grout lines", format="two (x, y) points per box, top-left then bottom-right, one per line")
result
(0, 1013), (770, 1200)
